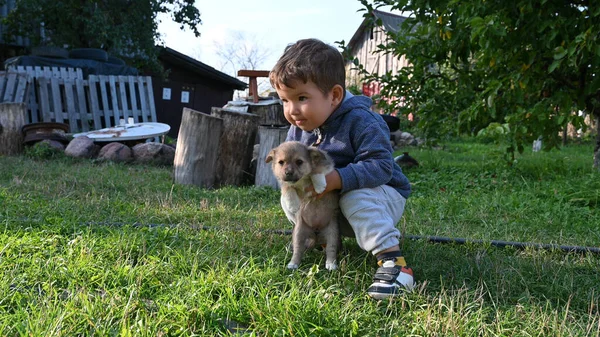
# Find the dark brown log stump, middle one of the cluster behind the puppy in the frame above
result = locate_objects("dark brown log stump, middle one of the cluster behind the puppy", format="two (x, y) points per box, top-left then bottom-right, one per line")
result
(211, 108), (258, 187)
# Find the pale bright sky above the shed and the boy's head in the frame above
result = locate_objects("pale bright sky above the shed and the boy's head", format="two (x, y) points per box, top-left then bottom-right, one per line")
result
(159, 0), (364, 72)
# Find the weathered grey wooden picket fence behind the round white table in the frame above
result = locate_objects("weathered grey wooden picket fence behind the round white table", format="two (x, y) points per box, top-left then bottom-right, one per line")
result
(5, 67), (156, 133)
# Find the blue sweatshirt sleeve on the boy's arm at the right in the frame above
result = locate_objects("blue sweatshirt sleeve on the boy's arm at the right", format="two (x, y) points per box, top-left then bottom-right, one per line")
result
(337, 122), (394, 193)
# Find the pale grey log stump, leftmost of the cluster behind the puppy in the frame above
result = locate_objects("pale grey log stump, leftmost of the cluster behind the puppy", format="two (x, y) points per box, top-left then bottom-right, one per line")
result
(173, 108), (223, 188)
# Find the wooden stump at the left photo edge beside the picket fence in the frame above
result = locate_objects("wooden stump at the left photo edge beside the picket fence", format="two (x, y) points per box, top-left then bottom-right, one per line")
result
(0, 103), (27, 155)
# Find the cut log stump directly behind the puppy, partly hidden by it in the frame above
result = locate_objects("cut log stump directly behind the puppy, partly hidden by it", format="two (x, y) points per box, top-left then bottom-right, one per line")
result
(255, 126), (289, 188)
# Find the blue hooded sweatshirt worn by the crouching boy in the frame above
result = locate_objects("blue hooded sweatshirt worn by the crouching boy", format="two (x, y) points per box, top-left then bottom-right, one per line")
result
(286, 91), (410, 198)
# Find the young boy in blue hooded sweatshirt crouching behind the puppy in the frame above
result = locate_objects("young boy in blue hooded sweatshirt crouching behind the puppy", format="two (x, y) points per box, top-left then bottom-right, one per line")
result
(269, 39), (414, 299)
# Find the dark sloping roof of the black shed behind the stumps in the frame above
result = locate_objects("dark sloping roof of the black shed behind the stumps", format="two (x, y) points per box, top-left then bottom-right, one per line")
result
(158, 47), (248, 90)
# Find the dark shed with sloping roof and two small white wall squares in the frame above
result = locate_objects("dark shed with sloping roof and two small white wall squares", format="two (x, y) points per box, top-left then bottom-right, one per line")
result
(153, 47), (247, 138)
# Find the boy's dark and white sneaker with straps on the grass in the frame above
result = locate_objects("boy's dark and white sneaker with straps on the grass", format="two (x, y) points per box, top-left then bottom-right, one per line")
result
(367, 258), (415, 300)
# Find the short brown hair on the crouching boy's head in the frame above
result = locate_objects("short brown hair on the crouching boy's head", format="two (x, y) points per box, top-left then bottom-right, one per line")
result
(269, 39), (346, 94)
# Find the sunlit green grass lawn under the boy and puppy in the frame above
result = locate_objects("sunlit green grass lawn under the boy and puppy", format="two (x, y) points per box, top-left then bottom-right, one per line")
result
(0, 142), (600, 336)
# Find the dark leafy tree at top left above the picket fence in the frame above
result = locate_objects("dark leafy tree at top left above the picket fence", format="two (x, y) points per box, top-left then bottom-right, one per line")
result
(0, 0), (201, 70)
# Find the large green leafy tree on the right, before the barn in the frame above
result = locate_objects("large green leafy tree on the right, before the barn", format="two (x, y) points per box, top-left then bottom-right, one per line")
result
(346, 0), (600, 165)
